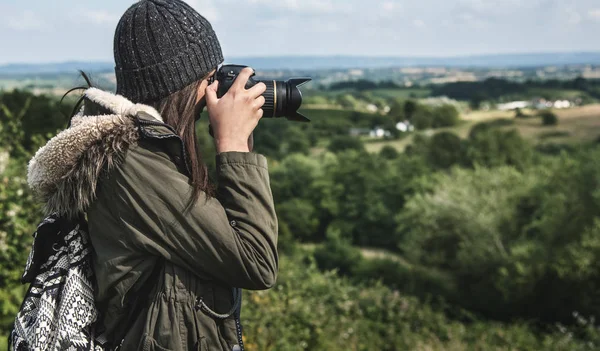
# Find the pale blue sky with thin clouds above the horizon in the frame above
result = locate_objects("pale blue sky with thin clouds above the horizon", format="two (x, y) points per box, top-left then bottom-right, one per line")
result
(0, 0), (600, 64)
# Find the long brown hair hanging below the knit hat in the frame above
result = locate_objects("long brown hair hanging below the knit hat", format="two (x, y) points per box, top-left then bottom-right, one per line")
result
(151, 78), (214, 211)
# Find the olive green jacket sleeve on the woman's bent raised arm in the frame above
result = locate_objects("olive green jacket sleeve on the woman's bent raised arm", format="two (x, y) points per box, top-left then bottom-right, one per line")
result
(111, 140), (278, 290)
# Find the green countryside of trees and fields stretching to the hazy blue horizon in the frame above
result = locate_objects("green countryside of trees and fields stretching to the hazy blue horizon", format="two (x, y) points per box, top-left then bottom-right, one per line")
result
(0, 54), (600, 351)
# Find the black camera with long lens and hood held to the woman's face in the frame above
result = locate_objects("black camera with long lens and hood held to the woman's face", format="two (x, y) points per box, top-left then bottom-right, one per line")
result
(211, 65), (311, 122)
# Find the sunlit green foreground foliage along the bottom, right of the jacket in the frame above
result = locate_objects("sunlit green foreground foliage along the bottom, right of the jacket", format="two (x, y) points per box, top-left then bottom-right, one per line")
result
(242, 257), (598, 351)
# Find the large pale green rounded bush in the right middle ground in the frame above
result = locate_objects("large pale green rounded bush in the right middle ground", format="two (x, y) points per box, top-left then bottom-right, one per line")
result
(397, 167), (535, 318)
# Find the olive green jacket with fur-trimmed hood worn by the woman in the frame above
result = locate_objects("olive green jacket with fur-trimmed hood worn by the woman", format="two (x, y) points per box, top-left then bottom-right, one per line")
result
(28, 89), (278, 350)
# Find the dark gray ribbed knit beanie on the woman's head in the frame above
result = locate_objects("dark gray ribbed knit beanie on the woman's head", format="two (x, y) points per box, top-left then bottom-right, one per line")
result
(114, 0), (223, 103)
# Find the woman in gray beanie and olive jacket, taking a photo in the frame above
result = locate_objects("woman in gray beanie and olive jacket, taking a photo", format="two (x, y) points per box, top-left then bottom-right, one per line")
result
(30, 0), (278, 350)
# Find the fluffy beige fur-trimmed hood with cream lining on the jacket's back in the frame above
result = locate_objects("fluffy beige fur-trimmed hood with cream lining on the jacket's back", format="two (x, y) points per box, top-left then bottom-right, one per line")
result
(27, 88), (162, 217)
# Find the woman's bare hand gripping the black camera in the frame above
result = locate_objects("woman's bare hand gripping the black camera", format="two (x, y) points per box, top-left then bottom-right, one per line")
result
(206, 67), (267, 153)
